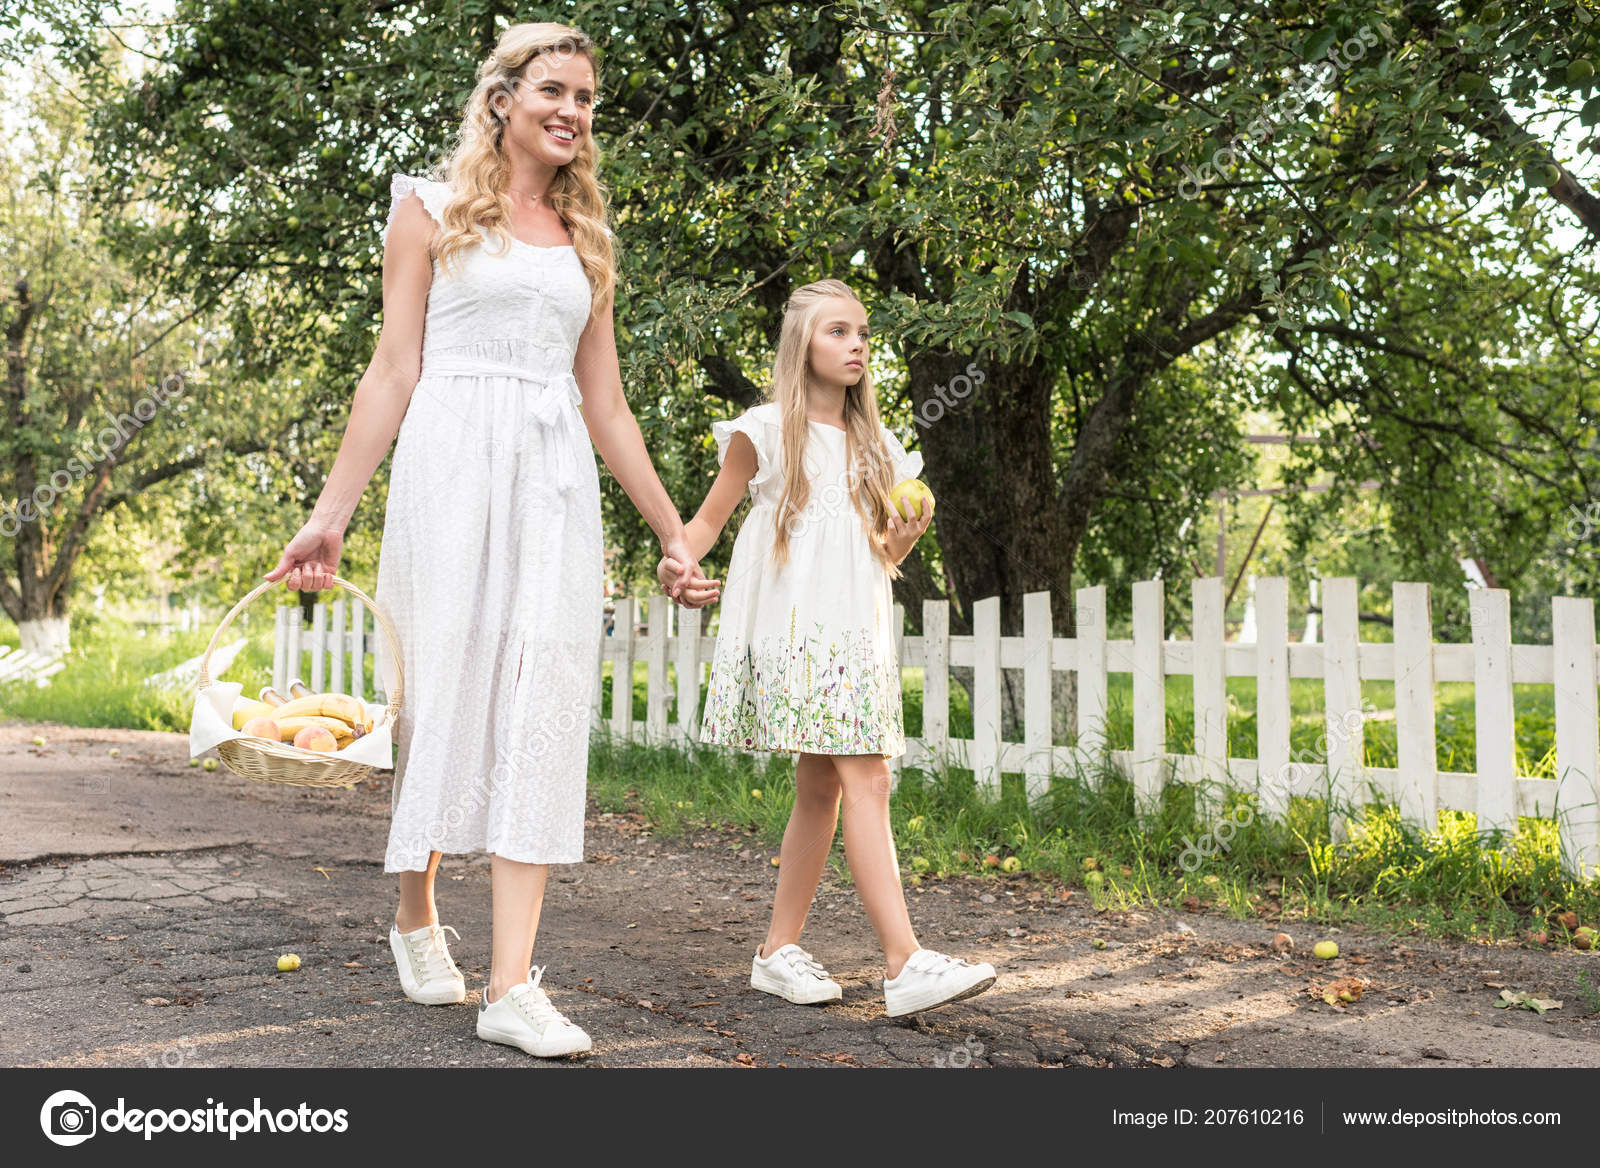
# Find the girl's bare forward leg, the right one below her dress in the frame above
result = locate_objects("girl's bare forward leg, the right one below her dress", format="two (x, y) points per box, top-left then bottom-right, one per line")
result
(832, 754), (920, 978)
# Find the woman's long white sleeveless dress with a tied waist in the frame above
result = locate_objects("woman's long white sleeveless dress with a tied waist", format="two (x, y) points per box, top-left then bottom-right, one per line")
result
(374, 174), (603, 872)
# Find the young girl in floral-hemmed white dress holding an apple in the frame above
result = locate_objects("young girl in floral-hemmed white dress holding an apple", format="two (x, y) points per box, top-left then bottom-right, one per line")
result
(658, 280), (995, 1016)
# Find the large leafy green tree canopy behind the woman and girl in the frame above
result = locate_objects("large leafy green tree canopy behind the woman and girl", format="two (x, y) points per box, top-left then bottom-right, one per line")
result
(6, 0), (1600, 634)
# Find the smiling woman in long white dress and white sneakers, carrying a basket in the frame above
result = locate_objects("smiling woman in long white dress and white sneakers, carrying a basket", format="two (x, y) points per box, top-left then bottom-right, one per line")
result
(267, 22), (699, 1056)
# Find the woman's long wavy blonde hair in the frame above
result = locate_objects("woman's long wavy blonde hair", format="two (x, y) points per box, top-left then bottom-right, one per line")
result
(427, 21), (616, 312)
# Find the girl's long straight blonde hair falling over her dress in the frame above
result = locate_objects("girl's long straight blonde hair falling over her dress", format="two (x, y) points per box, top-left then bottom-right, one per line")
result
(768, 280), (901, 579)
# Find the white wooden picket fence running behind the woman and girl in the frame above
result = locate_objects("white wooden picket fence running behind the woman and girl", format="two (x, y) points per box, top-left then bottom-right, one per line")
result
(274, 576), (1600, 872)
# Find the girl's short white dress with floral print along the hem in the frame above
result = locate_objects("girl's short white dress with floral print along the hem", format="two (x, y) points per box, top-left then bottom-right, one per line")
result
(701, 402), (922, 758)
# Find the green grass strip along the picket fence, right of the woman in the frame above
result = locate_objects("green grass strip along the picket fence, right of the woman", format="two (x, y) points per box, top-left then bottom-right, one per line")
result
(589, 731), (1600, 944)
